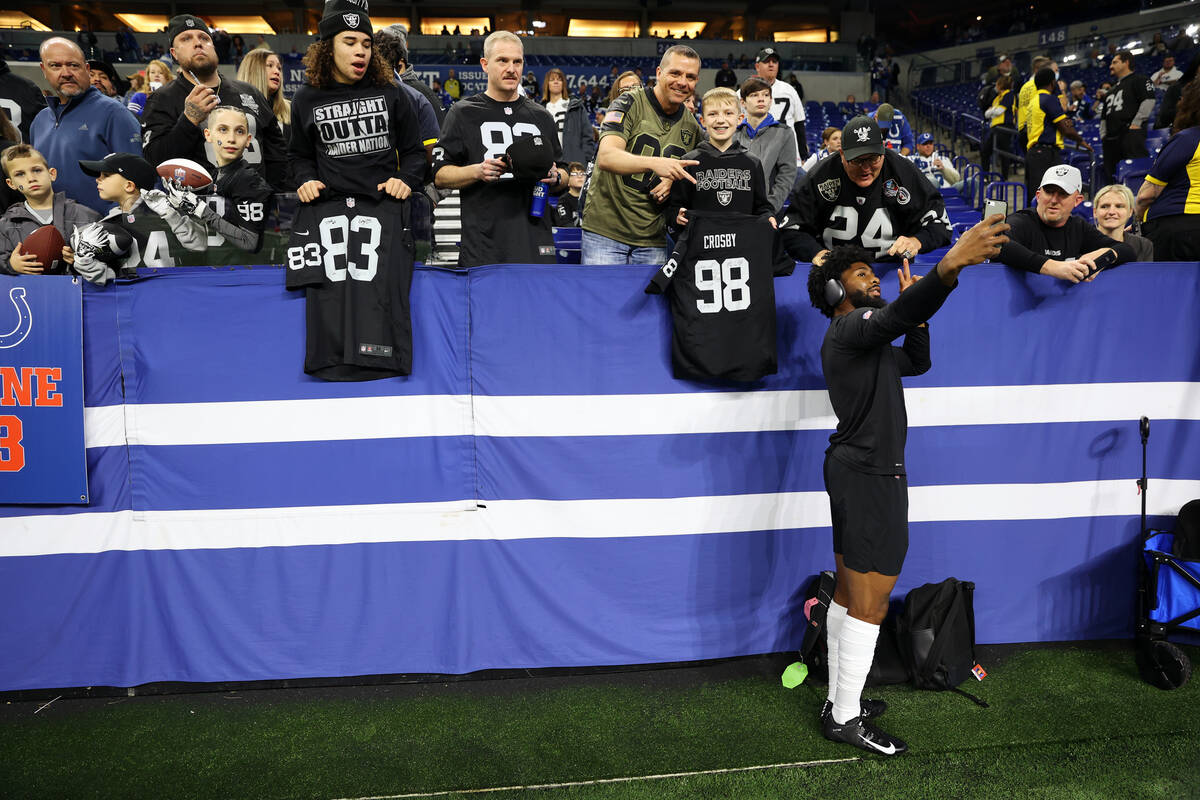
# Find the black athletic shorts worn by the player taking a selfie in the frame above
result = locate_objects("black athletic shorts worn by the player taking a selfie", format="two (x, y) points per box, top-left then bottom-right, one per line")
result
(824, 455), (908, 575)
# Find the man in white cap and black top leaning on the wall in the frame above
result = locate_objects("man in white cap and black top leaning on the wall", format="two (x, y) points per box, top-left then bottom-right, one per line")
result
(996, 164), (1135, 283)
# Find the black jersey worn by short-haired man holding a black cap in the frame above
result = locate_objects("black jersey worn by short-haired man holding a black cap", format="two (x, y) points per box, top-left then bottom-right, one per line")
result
(433, 94), (563, 266)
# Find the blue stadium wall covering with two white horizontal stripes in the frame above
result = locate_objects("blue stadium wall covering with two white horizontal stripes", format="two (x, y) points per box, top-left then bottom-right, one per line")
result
(0, 264), (1200, 690)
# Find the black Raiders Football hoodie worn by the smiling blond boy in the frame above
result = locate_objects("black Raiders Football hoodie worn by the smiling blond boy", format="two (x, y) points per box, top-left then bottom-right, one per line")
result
(666, 142), (775, 237)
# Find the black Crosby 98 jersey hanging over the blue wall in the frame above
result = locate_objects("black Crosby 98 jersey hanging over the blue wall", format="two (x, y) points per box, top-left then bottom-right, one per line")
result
(646, 211), (796, 381)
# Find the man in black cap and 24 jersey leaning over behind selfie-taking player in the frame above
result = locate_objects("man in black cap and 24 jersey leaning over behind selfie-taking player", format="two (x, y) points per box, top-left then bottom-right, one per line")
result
(780, 116), (950, 264)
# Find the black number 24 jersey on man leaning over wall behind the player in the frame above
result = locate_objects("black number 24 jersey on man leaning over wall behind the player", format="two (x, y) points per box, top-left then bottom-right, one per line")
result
(780, 150), (950, 261)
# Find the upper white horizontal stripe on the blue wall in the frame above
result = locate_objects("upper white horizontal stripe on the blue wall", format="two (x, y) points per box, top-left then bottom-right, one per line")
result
(85, 383), (1200, 447)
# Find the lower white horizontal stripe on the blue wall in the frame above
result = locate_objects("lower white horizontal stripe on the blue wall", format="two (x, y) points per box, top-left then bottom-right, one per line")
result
(0, 480), (1200, 557)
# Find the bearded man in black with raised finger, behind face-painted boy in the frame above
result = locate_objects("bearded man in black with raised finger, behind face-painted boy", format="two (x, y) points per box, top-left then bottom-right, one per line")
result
(142, 14), (292, 192)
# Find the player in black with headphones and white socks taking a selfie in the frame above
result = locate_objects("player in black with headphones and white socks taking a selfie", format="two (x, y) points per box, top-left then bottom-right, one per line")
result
(809, 213), (1008, 756)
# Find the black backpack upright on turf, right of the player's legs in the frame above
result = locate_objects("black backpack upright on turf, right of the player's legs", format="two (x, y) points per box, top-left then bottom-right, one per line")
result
(901, 578), (988, 708)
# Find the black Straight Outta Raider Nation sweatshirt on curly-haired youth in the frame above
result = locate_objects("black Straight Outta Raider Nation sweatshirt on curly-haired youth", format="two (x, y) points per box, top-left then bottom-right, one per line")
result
(288, 79), (425, 199)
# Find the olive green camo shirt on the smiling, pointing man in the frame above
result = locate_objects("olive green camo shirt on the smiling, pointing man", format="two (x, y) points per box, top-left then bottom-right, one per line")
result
(582, 89), (703, 247)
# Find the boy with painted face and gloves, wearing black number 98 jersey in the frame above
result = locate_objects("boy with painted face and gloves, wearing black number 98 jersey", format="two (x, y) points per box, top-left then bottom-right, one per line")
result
(163, 106), (271, 253)
